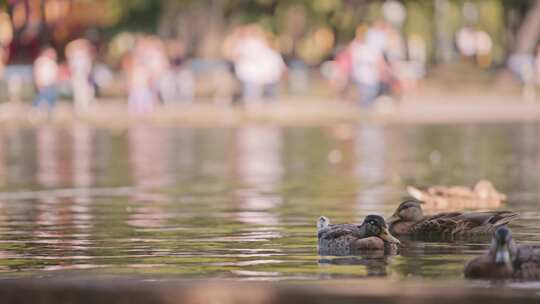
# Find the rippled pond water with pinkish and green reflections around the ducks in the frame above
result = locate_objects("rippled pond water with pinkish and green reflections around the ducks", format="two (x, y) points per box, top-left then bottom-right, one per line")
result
(0, 124), (540, 288)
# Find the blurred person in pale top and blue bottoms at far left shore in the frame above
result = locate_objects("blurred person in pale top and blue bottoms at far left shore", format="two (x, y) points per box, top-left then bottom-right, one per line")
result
(33, 47), (58, 110)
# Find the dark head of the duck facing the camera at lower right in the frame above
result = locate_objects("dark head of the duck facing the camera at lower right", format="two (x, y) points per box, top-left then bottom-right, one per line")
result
(489, 226), (517, 269)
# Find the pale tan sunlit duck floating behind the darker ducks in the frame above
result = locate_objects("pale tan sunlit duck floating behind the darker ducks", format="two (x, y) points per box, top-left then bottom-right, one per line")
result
(407, 180), (506, 210)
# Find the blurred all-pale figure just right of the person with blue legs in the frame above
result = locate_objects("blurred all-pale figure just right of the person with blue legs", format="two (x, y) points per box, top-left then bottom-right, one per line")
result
(66, 39), (95, 113)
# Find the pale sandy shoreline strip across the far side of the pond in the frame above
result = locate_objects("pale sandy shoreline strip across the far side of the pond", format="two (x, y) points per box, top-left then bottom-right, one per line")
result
(0, 96), (540, 128)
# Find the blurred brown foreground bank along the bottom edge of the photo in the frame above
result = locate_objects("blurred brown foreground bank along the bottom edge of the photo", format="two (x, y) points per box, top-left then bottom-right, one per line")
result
(0, 277), (539, 304)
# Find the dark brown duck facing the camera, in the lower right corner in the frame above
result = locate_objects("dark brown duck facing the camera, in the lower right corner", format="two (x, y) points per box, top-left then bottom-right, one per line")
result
(464, 227), (540, 279)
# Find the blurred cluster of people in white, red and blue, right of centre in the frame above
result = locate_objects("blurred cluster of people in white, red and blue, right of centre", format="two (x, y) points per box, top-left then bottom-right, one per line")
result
(322, 20), (426, 107)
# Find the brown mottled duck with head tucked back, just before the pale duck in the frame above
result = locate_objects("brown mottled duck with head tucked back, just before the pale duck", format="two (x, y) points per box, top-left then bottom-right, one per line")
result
(387, 200), (518, 237)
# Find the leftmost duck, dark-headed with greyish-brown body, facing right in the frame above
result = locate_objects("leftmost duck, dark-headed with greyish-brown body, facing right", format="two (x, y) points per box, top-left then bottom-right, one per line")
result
(317, 215), (400, 255)
